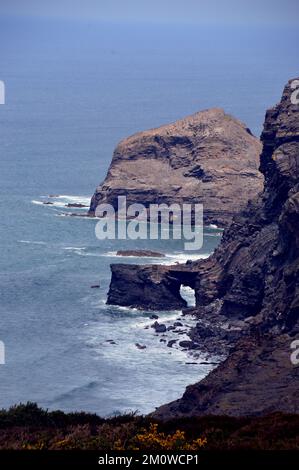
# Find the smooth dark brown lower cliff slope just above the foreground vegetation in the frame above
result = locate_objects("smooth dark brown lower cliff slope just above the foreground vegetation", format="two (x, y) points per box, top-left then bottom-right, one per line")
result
(153, 335), (299, 420)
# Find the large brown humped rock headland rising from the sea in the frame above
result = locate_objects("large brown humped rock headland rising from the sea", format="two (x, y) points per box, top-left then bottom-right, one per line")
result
(89, 109), (262, 226)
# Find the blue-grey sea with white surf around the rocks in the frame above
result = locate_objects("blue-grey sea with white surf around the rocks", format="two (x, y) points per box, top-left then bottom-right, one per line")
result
(0, 18), (298, 415)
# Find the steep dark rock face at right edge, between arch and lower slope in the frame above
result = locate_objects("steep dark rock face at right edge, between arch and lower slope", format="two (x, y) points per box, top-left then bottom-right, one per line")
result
(196, 78), (299, 328)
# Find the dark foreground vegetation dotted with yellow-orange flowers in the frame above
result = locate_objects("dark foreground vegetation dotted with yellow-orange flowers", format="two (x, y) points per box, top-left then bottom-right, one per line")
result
(0, 403), (299, 451)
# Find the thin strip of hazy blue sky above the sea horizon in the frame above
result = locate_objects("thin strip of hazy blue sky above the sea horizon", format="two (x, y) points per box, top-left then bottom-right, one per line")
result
(0, 0), (299, 25)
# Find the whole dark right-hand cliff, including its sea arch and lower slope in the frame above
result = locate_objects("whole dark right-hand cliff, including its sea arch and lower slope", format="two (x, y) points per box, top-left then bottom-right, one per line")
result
(106, 82), (299, 418)
